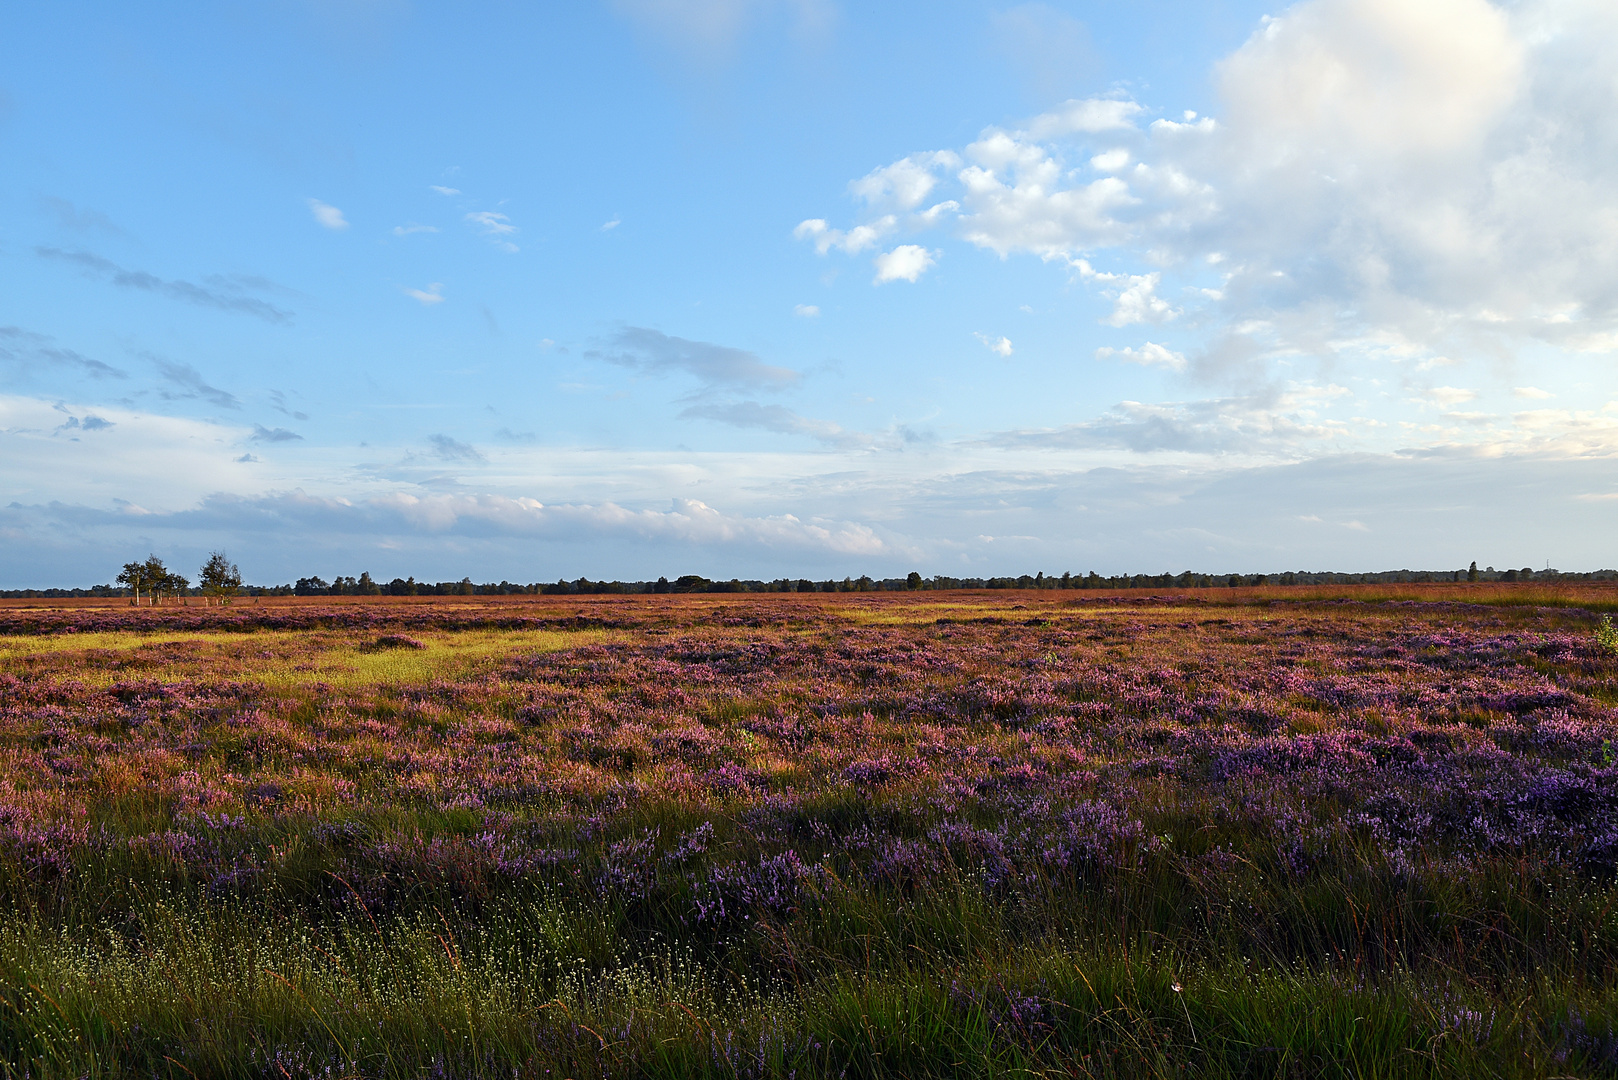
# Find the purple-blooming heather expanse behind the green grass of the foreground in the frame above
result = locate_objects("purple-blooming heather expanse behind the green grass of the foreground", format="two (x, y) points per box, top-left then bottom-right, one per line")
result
(0, 594), (1618, 1072)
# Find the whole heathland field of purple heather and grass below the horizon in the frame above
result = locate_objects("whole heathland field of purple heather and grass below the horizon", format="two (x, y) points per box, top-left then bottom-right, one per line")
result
(0, 586), (1618, 1080)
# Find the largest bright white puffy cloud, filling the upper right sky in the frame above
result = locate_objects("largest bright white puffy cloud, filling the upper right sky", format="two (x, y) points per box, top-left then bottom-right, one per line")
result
(807, 0), (1618, 376)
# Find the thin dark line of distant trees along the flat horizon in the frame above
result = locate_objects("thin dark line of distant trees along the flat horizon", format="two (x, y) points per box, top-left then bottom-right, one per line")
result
(0, 563), (1618, 599)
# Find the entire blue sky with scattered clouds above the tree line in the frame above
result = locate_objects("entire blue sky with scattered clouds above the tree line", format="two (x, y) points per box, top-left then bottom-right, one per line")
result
(0, 0), (1618, 588)
